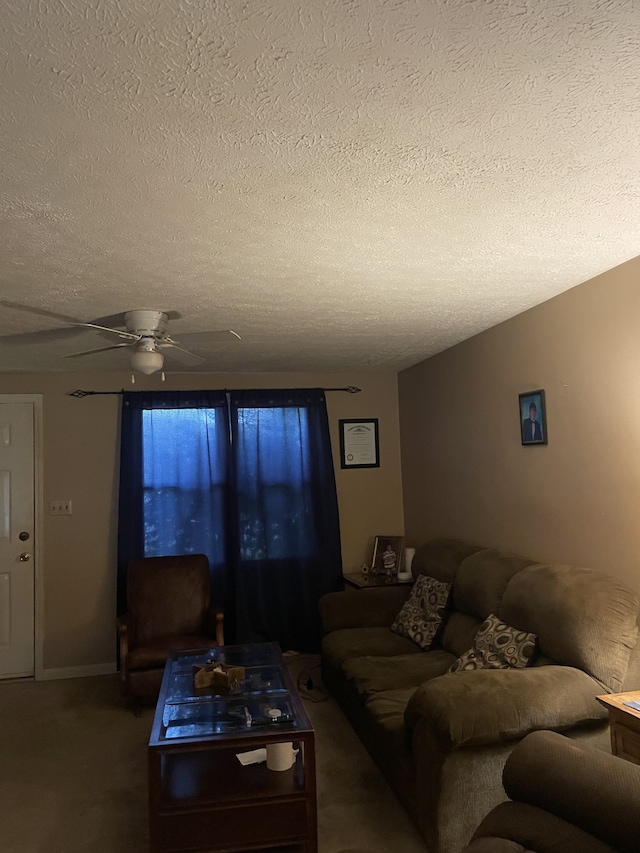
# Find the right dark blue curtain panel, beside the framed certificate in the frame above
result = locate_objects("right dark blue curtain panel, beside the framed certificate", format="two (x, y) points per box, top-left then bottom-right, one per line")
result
(230, 389), (342, 651)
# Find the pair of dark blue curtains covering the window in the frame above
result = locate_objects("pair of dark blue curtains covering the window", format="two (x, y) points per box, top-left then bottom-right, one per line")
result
(118, 389), (342, 651)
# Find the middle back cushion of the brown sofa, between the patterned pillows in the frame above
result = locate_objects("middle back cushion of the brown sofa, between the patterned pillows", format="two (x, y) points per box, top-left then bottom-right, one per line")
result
(441, 548), (534, 657)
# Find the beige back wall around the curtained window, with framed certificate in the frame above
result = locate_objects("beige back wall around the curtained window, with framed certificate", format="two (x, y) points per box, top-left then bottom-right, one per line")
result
(0, 373), (403, 677)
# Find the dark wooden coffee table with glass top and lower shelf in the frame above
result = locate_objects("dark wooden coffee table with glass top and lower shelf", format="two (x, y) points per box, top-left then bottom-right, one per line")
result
(148, 643), (318, 853)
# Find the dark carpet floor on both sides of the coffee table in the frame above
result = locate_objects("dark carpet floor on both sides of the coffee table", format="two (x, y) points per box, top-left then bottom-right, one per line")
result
(0, 655), (426, 853)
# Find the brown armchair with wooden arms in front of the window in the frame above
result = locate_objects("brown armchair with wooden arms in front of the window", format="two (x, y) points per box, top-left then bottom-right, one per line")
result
(117, 554), (224, 703)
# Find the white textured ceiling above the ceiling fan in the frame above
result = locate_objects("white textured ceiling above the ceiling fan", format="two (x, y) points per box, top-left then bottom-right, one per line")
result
(0, 0), (640, 372)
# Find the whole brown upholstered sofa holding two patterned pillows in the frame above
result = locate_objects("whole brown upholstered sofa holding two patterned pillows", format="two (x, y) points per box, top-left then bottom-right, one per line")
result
(320, 539), (640, 853)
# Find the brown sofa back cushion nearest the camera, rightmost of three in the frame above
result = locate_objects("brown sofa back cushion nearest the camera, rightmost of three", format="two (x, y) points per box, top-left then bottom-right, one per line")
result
(496, 564), (639, 692)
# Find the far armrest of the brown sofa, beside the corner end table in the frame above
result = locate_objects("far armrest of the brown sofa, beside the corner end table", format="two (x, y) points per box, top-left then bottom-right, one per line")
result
(320, 584), (411, 634)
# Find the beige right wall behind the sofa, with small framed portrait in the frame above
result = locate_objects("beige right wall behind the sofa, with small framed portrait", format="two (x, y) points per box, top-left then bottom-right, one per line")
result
(398, 259), (640, 592)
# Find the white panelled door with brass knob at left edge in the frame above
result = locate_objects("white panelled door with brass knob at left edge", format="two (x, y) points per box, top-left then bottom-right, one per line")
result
(0, 401), (35, 678)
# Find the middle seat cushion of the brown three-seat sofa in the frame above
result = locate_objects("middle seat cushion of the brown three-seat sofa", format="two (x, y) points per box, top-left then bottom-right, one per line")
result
(342, 649), (452, 697)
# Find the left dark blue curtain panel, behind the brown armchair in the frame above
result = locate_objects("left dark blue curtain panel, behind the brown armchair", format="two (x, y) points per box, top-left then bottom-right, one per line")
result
(117, 391), (233, 615)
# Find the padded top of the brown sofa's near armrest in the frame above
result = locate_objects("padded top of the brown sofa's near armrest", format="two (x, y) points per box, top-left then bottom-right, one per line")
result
(405, 666), (607, 747)
